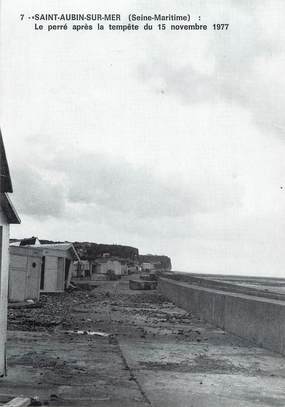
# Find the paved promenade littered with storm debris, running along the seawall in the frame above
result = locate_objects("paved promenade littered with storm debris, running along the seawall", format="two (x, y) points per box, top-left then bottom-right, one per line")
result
(0, 280), (285, 407)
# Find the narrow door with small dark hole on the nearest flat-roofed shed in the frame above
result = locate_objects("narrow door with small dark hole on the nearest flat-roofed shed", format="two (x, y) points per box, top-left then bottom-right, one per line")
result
(25, 257), (41, 300)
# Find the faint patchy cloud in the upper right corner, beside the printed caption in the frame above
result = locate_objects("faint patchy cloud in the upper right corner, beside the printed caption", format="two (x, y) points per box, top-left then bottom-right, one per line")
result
(138, 1), (285, 136)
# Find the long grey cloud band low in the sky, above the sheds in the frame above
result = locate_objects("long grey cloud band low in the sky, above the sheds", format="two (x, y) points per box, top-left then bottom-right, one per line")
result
(10, 144), (243, 230)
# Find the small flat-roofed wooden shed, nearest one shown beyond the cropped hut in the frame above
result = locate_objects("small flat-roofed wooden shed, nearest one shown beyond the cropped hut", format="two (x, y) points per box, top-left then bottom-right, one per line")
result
(9, 246), (42, 302)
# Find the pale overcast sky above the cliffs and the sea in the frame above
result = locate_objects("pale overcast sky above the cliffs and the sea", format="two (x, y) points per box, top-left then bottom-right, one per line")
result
(0, 0), (285, 276)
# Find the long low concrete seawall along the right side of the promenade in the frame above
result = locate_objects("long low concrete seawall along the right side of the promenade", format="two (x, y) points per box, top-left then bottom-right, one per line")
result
(158, 278), (285, 355)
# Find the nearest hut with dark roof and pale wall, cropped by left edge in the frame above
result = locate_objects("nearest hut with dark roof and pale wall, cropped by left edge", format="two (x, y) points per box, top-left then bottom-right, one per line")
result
(0, 132), (20, 376)
